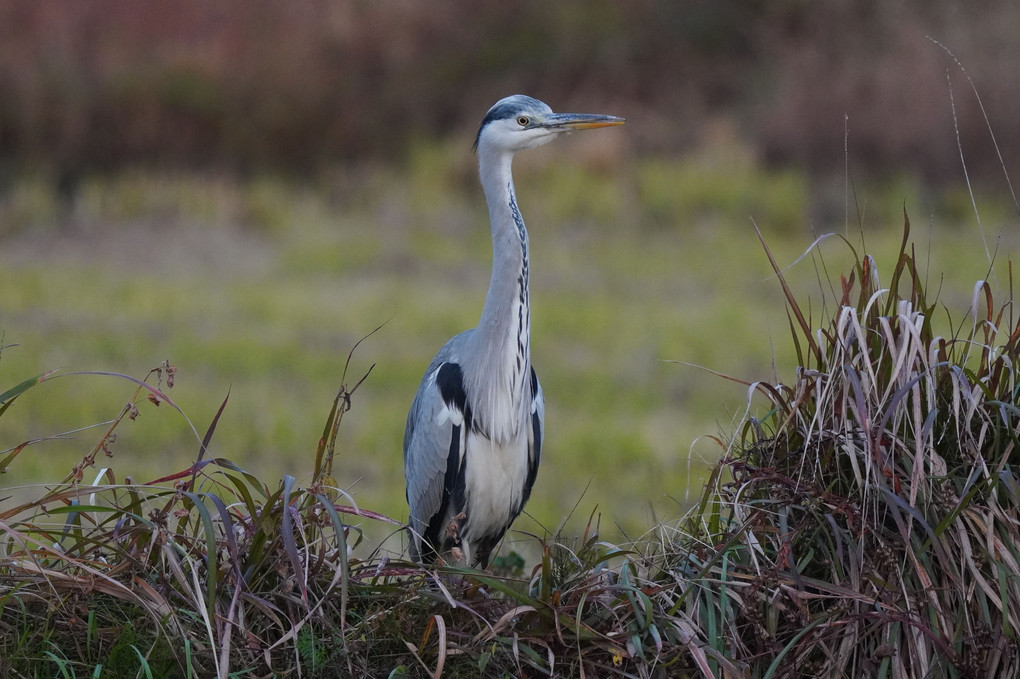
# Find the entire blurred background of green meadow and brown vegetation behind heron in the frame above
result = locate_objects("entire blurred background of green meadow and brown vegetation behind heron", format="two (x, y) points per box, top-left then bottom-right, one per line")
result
(0, 0), (1020, 537)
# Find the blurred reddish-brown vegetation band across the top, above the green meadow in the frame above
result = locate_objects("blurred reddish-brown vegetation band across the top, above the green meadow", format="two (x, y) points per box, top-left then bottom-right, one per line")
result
(0, 0), (1020, 180)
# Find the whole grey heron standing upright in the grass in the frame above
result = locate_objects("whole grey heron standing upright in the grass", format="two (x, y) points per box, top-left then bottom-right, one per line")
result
(404, 95), (624, 568)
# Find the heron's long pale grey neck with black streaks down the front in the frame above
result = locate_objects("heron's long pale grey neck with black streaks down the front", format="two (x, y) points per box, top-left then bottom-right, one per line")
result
(466, 149), (531, 441)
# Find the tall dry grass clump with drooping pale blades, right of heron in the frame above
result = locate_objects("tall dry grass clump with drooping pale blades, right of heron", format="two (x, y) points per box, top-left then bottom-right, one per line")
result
(669, 214), (1020, 677)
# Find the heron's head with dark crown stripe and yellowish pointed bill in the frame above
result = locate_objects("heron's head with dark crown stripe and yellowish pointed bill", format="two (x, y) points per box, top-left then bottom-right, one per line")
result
(474, 95), (624, 153)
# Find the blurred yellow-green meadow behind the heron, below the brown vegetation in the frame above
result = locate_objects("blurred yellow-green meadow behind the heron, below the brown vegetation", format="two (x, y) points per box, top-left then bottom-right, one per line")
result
(0, 136), (1020, 539)
